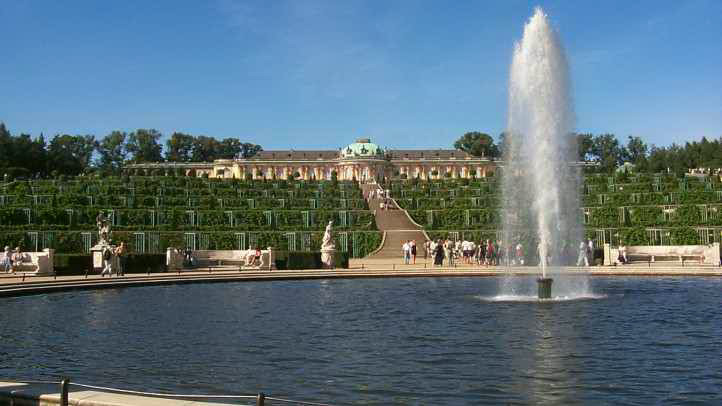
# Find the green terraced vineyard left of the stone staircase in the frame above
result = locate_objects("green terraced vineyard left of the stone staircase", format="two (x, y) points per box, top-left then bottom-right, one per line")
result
(0, 176), (381, 257)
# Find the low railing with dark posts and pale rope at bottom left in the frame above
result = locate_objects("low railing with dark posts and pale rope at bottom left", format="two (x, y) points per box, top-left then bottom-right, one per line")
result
(0, 377), (331, 406)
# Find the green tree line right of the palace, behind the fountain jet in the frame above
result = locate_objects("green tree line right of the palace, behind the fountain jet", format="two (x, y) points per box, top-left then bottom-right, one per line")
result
(454, 131), (722, 174)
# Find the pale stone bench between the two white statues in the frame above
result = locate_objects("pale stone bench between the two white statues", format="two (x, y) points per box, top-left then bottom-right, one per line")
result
(166, 248), (276, 270)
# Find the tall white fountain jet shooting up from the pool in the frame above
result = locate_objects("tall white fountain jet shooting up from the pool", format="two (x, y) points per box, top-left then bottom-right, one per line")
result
(503, 8), (587, 299)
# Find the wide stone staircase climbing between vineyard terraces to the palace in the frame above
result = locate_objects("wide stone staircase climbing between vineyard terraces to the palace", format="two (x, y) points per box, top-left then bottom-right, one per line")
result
(361, 184), (426, 260)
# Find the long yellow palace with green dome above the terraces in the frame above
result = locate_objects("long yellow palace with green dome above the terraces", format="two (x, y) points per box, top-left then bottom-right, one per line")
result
(124, 138), (496, 181)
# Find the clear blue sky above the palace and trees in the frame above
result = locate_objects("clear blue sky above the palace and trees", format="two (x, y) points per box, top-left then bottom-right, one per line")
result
(0, 0), (722, 149)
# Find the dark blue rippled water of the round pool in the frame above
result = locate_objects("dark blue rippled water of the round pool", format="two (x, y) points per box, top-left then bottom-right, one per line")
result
(0, 278), (722, 405)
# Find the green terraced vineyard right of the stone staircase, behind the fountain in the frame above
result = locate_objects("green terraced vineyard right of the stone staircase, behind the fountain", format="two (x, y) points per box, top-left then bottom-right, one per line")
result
(391, 174), (722, 252)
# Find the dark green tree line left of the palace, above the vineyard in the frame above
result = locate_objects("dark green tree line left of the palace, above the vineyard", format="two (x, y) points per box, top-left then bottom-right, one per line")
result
(0, 122), (262, 178)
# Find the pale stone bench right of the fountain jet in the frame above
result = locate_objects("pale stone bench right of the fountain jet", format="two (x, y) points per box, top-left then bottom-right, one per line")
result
(604, 243), (720, 265)
